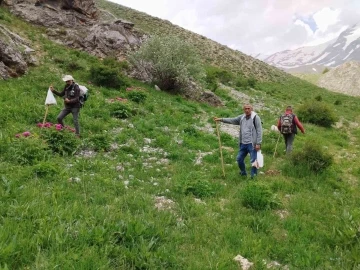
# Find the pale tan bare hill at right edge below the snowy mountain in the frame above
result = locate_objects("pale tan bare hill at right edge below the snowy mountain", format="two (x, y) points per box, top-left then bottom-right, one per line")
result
(318, 61), (360, 96)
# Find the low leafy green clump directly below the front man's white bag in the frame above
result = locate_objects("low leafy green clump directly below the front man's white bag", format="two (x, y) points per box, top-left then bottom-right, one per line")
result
(240, 183), (280, 210)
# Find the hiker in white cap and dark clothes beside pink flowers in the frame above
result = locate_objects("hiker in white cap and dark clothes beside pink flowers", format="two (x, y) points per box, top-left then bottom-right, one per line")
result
(50, 75), (81, 136)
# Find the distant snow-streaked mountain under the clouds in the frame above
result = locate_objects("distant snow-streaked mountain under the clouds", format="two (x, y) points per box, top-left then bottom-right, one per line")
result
(258, 23), (360, 73)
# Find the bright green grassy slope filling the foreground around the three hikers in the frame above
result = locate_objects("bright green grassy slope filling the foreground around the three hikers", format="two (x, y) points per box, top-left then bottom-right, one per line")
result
(0, 2), (360, 270)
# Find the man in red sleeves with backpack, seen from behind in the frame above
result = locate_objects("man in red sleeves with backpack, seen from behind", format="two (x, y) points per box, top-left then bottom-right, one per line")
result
(277, 106), (305, 154)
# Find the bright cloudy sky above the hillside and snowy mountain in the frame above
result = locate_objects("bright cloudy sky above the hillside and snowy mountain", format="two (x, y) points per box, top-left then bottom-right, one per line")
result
(110, 0), (360, 55)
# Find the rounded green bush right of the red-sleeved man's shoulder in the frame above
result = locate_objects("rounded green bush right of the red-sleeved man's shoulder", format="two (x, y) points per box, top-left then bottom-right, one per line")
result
(298, 101), (337, 127)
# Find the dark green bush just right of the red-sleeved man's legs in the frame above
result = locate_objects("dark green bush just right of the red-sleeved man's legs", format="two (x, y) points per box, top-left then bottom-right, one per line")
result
(291, 141), (333, 173)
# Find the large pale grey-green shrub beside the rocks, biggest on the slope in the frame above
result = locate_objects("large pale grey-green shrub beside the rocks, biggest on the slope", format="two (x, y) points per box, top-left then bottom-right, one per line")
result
(129, 36), (202, 92)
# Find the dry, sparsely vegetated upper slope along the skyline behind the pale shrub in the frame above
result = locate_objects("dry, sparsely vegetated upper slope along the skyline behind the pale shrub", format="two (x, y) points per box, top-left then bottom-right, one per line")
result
(96, 0), (289, 81)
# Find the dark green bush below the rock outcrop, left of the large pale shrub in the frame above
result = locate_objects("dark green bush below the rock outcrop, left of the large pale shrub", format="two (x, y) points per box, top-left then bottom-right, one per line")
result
(90, 64), (128, 88)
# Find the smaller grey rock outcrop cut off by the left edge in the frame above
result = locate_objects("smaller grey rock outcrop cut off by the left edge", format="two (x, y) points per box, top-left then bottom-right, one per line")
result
(0, 25), (36, 79)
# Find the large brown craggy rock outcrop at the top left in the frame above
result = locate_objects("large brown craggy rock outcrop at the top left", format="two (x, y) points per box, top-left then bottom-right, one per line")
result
(5, 0), (143, 60)
